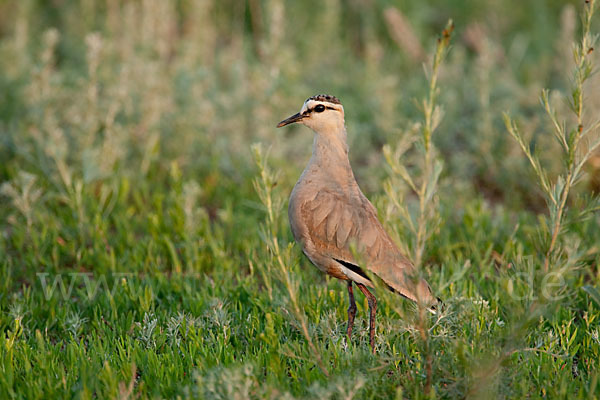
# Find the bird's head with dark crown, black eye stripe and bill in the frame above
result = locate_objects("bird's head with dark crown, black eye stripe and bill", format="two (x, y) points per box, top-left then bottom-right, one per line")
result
(277, 94), (344, 134)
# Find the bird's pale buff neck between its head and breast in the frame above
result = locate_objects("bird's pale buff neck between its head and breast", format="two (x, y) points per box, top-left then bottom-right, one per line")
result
(309, 126), (355, 185)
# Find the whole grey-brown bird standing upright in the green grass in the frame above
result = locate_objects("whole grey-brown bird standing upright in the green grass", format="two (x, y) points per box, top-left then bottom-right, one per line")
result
(277, 94), (442, 353)
